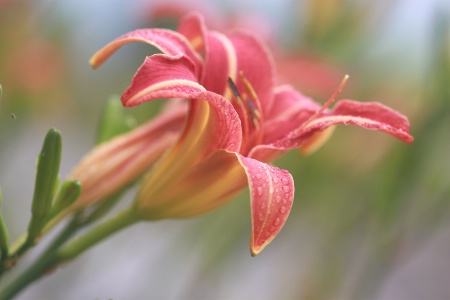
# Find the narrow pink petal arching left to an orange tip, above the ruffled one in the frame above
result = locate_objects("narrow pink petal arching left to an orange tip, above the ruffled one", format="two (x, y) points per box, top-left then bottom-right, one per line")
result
(90, 29), (203, 75)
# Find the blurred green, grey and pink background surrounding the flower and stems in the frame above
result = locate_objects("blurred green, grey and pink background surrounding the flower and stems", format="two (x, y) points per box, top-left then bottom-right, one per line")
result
(0, 0), (450, 300)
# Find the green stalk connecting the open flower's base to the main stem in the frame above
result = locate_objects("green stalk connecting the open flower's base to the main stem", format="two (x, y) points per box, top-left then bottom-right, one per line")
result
(58, 207), (140, 262)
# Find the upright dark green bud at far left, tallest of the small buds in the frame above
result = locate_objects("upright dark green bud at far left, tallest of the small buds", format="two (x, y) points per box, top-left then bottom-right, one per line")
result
(27, 128), (62, 243)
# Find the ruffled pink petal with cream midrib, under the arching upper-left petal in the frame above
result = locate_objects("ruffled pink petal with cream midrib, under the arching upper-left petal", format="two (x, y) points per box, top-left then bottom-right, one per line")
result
(122, 54), (205, 106)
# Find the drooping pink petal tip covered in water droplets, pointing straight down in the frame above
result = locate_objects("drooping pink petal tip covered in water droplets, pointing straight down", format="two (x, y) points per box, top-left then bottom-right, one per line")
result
(238, 155), (294, 256)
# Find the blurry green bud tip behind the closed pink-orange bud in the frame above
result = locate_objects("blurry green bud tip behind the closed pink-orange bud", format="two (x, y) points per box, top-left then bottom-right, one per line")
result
(96, 96), (136, 144)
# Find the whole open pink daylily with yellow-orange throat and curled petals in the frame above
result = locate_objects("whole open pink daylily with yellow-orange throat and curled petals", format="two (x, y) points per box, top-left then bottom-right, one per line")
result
(91, 14), (413, 255)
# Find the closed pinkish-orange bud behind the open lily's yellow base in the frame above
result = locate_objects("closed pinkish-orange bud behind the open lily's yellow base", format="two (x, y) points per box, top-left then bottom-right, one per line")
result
(69, 103), (186, 208)
